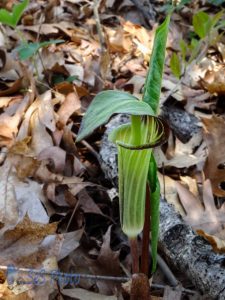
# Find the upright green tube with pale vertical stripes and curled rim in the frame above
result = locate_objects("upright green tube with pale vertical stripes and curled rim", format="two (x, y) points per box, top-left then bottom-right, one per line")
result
(109, 117), (166, 238)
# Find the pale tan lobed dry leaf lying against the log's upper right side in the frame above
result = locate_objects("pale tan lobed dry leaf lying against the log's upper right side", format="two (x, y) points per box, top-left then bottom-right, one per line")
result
(166, 177), (225, 252)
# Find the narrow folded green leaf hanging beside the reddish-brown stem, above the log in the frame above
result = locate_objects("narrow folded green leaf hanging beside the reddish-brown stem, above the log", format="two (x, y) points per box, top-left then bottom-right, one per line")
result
(150, 177), (160, 273)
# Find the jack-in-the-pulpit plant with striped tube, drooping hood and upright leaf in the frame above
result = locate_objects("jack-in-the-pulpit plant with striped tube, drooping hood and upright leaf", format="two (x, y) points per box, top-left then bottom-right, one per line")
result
(77, 16), (170, 271)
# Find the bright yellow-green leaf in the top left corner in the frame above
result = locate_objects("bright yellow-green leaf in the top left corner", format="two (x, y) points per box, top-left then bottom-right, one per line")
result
(0, 0), (29, 28)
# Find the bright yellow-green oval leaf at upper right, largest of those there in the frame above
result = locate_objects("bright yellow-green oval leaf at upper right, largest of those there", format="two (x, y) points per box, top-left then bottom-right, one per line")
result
(192, 11), (212, 39)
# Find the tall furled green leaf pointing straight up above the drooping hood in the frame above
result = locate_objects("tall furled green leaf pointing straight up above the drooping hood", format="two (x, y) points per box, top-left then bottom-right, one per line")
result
(143, 15), (170, 113)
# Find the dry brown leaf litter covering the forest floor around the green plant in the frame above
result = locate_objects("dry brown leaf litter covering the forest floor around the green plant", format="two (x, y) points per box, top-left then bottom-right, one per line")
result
(0, 0), (225, 299)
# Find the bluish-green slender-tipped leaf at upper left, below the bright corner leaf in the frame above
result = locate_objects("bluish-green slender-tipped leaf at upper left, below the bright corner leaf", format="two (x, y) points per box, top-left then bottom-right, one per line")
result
(16, 40), (64, 61)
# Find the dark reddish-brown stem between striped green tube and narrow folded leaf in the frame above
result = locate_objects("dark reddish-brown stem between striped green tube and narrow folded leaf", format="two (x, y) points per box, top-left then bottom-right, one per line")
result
(141, 183), (151, 276)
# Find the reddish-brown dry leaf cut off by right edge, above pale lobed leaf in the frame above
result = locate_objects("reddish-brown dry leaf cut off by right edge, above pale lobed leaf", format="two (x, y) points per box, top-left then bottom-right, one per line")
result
(202, 116), (225, 197)
